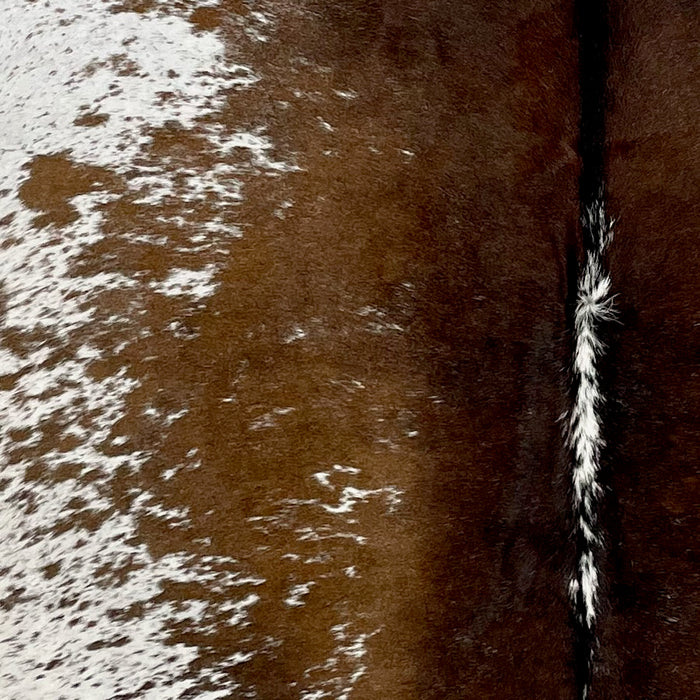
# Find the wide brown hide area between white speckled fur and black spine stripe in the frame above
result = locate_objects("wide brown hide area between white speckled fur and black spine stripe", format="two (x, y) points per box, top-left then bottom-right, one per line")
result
(146, 2), (579, 700)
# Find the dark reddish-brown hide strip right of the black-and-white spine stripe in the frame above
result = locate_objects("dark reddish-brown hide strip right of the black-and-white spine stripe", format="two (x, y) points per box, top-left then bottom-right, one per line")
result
(592, 1), (700, 698)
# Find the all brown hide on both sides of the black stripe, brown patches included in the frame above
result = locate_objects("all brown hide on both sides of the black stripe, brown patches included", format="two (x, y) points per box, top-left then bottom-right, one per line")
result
(0, 0), (700, 700)
